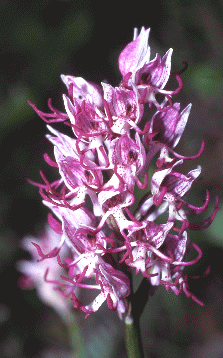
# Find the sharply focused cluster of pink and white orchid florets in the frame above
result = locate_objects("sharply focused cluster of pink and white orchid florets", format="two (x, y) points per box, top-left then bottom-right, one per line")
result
(20, 28), (218, 316)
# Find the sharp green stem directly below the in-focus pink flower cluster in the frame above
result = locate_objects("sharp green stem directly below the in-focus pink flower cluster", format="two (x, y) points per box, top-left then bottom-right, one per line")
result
(124, 316), (143, 358)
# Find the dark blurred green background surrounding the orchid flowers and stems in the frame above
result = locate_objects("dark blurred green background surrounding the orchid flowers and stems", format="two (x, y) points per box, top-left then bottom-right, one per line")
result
(0, 0), (223, 358)
